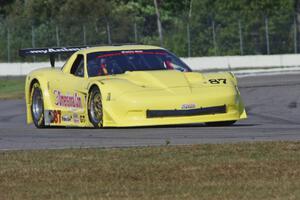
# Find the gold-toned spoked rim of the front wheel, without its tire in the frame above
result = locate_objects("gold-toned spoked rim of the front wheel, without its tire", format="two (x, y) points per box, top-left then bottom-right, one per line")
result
(90, 92), (102, 124)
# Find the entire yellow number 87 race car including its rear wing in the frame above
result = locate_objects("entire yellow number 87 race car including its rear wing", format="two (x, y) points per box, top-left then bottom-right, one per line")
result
(20, 45), (247, 128)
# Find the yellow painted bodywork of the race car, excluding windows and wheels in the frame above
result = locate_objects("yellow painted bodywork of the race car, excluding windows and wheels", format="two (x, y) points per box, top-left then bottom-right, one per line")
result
(25, 45), (247, 127)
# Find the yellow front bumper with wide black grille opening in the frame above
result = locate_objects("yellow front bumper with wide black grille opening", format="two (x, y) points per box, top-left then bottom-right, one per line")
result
(103, 87), (247, 127)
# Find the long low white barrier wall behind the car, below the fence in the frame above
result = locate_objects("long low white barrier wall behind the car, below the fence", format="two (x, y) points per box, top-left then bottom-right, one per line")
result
(0, 54), (300, 76)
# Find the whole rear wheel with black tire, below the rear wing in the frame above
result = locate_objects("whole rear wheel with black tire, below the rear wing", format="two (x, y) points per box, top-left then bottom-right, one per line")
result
(30, 82), (45, 128)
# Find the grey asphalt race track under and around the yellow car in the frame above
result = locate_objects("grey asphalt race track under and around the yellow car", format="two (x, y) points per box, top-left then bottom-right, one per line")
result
(0, 74), (300, 150)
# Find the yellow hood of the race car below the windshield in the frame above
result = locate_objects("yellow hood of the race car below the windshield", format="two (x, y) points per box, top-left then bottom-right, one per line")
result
(97, 70), (236, 97)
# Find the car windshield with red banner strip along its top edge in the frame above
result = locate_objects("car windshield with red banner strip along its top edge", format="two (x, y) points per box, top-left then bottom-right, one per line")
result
(87, 50), (191, 77)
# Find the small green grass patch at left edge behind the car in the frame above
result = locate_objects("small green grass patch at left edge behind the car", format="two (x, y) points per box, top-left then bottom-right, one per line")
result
(0, 76), (25, 99)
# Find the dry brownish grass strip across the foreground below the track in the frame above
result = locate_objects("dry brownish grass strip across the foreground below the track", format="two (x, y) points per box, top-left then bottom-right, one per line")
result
(0, 142), (300, 200)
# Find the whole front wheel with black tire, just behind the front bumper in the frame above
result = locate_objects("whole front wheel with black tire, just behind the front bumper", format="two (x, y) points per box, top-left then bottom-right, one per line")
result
(87, 87), (103, 128)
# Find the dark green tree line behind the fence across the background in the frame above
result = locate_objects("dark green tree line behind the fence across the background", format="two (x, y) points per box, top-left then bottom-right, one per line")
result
(0, 0), (300, 62)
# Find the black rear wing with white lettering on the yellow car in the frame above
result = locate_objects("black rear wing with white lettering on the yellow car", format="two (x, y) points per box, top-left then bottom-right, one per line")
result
(19, 46), (89, 67)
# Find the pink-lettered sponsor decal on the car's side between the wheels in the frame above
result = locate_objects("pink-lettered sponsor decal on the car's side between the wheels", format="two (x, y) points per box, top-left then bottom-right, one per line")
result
(54, 90), (82, 108)
